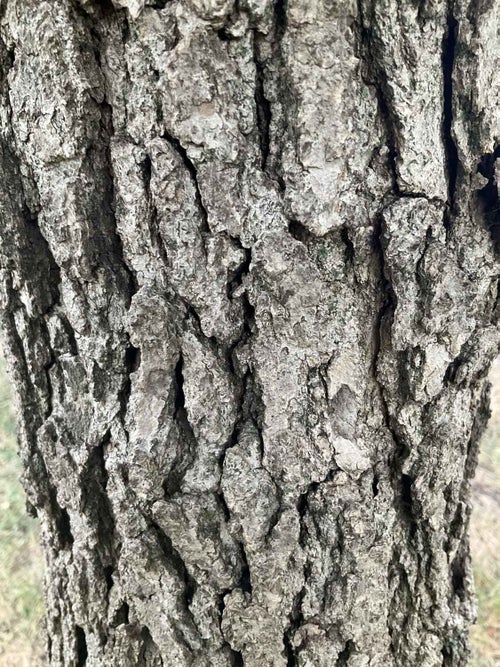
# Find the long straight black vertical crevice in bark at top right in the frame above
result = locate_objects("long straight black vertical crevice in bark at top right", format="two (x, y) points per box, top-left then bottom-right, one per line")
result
(442, 14), (459, 222)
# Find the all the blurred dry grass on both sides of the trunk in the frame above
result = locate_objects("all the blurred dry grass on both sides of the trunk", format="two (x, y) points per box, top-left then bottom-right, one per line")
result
(0, 359), (500, 667)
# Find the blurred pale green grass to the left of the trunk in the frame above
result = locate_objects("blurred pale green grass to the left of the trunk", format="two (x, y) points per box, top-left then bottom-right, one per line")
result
(0, 359), (43, 667)
